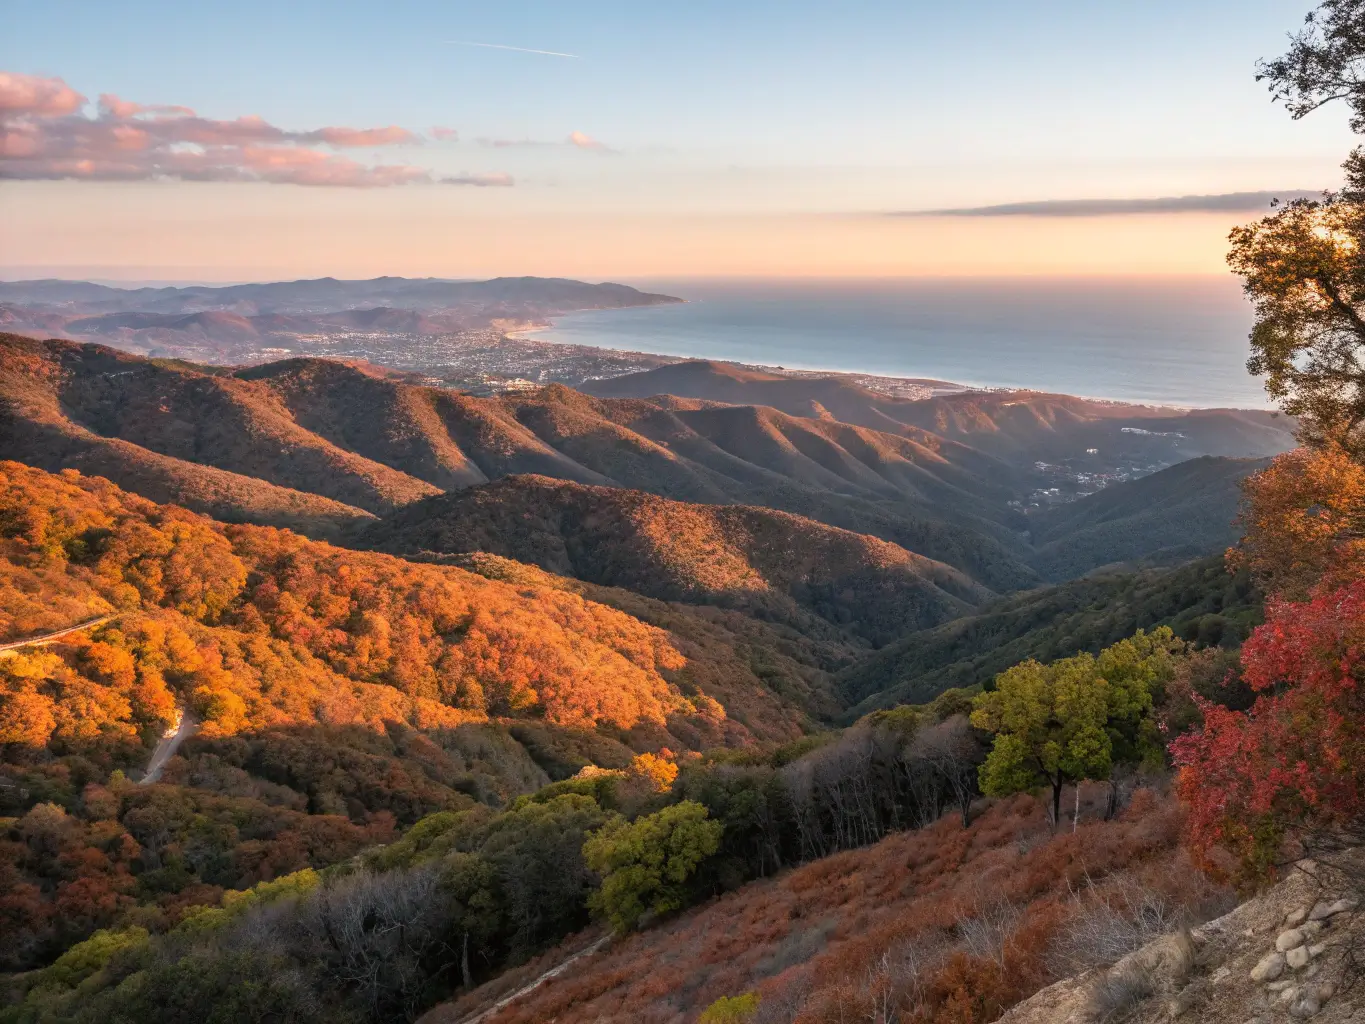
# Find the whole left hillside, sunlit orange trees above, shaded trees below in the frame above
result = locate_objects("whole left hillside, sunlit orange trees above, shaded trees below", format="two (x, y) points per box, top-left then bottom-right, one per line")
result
(0, 463), (829, 967)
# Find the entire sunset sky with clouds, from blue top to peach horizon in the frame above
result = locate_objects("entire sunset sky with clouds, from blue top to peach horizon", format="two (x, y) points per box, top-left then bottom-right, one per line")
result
(0, 0), (1353, 280)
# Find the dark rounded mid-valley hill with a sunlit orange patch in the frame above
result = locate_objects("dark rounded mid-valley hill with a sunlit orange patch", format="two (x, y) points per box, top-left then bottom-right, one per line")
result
(358, 477), (988, 643)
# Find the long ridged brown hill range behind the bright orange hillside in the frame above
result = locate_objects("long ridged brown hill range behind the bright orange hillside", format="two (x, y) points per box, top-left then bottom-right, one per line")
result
(0, 336), (1036, 588)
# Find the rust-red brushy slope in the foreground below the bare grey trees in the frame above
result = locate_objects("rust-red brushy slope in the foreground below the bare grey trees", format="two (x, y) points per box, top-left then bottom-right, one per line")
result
(456, 788), (1222, 1024)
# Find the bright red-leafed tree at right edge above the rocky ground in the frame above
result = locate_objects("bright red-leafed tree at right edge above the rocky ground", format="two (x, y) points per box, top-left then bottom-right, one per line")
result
(1171, 582), (1365, 872)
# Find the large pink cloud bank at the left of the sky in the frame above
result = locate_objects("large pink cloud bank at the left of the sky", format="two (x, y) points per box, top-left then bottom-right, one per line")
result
(0, 72), (512, 188)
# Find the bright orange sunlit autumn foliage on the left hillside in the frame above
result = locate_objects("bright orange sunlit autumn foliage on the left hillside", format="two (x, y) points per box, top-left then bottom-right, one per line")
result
(0, 463), (748, 747)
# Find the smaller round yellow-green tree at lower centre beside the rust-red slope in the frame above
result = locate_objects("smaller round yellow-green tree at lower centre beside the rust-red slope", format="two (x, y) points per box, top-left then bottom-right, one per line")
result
(583, 800), (723, 933)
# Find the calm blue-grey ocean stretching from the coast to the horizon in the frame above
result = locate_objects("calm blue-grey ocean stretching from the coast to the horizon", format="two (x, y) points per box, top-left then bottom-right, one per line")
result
(528, 276), (1269, 408)
